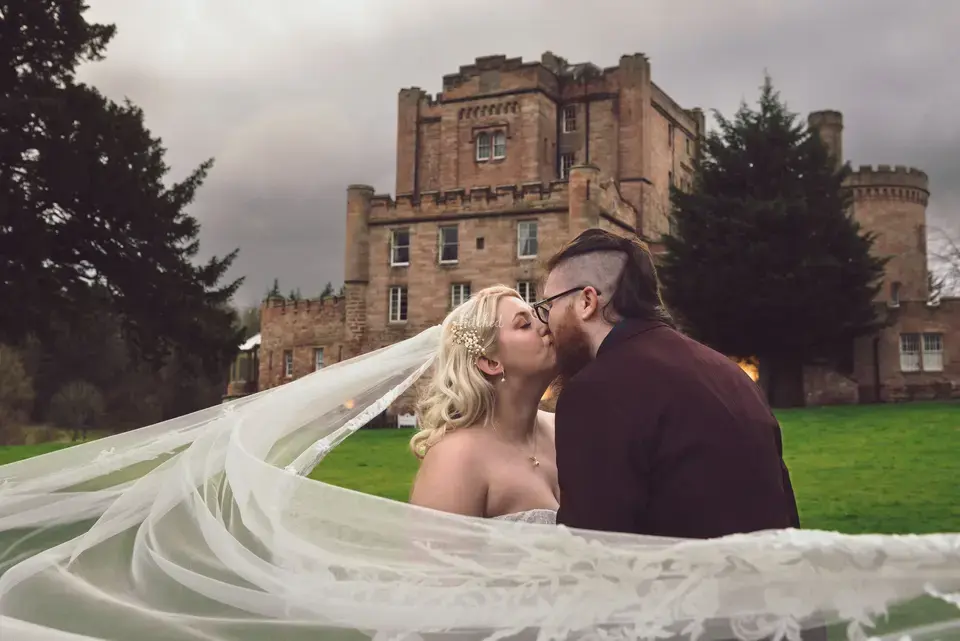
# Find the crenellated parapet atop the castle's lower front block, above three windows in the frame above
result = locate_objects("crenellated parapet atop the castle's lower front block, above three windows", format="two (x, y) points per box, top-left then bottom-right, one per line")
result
(370, 180), (569, 220)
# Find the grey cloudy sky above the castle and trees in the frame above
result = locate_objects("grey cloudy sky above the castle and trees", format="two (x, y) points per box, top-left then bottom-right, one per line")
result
(81, 0), (960, 304)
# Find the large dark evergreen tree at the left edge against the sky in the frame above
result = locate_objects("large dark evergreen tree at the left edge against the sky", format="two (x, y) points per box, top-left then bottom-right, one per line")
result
(0, 0), (242, 372)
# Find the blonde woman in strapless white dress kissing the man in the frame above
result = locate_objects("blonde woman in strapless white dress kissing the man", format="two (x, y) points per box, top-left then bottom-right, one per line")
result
(410, 286), (560, 523)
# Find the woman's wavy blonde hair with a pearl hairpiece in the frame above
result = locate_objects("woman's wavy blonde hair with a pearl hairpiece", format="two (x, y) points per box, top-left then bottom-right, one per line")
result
(410, 285), (523, 458)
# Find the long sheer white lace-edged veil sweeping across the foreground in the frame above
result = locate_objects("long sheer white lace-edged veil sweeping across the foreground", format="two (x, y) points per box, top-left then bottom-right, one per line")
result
(0, 327), (960, 641)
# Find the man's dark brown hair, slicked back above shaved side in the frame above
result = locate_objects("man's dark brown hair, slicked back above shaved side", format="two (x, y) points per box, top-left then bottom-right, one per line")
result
(546, 228), (676, 327)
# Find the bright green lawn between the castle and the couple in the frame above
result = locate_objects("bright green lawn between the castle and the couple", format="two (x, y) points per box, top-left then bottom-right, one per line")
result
(0, 403), (960, 534)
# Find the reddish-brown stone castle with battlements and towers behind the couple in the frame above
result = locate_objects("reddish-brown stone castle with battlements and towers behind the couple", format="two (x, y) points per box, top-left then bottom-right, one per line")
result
(227, 52), (960, 413)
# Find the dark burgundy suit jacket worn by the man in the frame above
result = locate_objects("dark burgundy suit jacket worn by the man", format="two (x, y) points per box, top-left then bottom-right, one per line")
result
(556, 320), (800, 539)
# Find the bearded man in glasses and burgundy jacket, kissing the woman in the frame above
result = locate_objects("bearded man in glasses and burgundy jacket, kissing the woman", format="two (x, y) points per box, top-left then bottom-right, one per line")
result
(534, 229), (799, 539)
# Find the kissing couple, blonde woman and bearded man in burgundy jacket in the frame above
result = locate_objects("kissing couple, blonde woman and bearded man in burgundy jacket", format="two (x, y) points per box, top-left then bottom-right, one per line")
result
(410, 229), (800, 539)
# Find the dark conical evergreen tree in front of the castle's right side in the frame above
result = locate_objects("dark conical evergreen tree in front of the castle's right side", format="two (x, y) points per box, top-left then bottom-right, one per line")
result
(659, 77), (887, 405)
